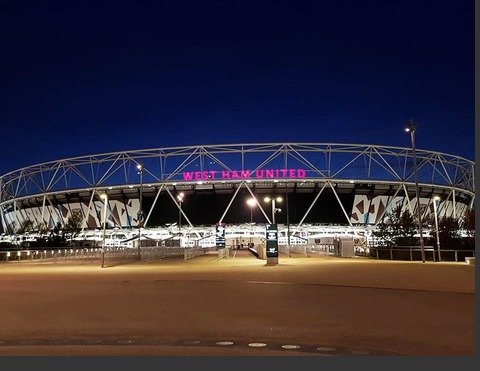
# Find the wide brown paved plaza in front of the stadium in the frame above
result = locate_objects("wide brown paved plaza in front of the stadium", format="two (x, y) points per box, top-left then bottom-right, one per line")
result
(0, 250), (476, 356)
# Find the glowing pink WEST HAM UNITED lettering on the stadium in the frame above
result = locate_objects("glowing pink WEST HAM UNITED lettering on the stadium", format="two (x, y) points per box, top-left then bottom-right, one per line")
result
(182, 169), (306, 181)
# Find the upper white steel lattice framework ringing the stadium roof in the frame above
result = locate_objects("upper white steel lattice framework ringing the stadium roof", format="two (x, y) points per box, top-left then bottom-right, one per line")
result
(0, 143), (475, 230)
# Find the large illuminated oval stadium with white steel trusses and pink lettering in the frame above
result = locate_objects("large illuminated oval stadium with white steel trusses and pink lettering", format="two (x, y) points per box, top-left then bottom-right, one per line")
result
(0, 143), (475, 247)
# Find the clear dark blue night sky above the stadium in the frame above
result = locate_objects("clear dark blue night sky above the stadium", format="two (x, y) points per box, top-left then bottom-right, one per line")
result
(0, 0), (475, 174)
